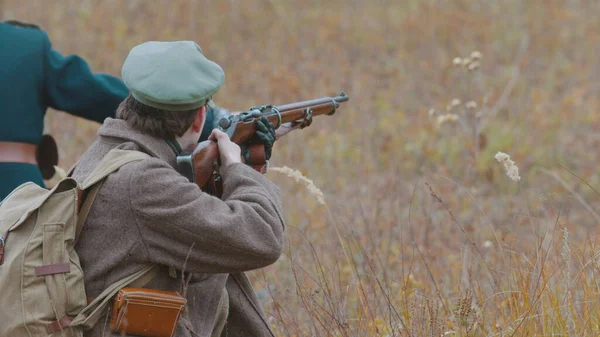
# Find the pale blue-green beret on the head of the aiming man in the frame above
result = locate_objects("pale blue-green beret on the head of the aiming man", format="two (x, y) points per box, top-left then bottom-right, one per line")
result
(121, 41), (225, 111)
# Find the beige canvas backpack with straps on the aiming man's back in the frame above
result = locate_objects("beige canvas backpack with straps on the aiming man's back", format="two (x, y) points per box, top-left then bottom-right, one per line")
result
(0, 149), (155, 337)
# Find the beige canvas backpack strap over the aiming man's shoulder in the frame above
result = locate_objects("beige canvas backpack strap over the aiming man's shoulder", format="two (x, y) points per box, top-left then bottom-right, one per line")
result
(75, 149), (150, 241)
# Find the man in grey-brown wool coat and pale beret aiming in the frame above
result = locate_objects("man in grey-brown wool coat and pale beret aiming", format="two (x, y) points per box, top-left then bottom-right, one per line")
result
(74, 41), (285, 337)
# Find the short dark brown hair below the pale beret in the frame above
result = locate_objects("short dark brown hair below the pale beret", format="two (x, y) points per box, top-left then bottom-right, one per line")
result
(117, 94), (198, 139)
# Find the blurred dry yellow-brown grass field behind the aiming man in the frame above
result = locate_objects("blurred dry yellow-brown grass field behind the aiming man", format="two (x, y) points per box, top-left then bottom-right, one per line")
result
(0, 0), (600, 337)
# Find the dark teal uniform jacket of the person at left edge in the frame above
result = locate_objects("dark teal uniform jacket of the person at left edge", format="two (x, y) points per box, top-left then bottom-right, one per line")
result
(0, 23), (129, 200)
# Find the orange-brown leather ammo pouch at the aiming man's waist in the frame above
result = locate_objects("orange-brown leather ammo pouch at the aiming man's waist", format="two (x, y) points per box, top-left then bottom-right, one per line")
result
(110, 288), (186, 337)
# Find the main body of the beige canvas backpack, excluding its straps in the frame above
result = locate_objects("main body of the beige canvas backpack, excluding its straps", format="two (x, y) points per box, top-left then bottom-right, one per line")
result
(0, 179), (87, 337)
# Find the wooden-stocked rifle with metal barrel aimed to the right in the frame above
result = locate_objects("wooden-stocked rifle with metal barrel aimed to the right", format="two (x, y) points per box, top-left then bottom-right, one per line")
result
(177, 92), (349, 196)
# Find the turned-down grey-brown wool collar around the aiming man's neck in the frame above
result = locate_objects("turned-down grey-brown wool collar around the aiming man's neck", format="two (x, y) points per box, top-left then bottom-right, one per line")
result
(98, 118), (177, 168)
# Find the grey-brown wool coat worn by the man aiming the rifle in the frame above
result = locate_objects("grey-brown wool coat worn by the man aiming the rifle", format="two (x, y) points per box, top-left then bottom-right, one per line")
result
(73, 118), (285, 337)
